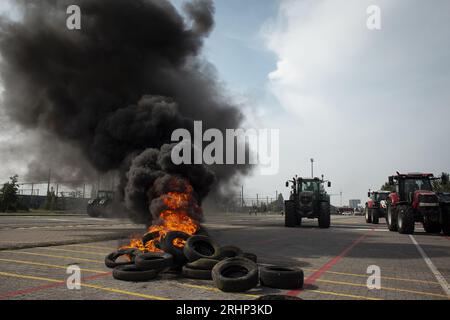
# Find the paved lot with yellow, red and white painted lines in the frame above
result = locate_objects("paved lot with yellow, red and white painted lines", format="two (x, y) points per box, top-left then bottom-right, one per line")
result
(0, 214), (450, 300)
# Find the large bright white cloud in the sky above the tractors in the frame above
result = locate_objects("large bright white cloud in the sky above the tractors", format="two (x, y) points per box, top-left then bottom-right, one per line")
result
(265, 0), (450, 204)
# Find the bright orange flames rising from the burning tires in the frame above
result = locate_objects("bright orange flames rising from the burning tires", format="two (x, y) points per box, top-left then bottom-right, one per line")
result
(121, 185), (201, 252)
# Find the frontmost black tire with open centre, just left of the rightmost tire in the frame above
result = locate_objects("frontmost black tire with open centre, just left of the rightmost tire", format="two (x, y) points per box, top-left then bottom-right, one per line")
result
(212, 257), (258, 292)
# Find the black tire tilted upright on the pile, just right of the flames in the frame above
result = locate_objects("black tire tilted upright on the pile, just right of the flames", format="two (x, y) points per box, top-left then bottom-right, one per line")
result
(183, 236), (220, 262)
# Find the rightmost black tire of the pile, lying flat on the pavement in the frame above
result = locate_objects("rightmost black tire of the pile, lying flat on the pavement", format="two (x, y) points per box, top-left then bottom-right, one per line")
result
(259, 266), (304, 290)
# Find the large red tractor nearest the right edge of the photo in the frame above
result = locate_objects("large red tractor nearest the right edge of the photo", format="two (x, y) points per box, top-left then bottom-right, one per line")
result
(386, 172), (450, 235)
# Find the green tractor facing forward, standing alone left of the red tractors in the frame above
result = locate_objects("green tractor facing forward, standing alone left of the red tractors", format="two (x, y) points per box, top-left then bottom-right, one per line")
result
(284, 176), (331, 229)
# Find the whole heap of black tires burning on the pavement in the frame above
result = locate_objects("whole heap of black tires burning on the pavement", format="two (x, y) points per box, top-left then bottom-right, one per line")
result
(105, 231), (303, 292)
